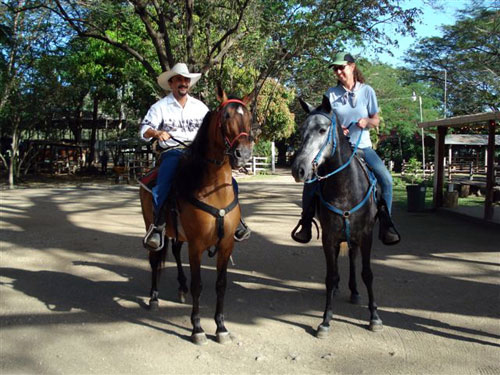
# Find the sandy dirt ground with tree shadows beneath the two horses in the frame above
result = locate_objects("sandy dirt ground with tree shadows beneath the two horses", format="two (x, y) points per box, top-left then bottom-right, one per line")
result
(0, 175), (500, 375)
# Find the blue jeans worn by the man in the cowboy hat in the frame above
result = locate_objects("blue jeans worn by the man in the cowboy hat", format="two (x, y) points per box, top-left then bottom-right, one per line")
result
(152, 149), (238, 217)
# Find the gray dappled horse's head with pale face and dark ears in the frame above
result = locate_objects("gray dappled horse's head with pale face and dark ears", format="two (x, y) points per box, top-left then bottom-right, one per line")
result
(292, 96), (336, 182)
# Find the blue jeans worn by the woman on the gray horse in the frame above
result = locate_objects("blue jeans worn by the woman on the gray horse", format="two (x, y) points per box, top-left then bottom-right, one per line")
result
(302, 147), (392, 214)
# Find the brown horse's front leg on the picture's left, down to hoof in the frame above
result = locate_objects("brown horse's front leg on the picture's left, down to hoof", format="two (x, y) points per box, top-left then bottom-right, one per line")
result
(189, 244), (208, 345)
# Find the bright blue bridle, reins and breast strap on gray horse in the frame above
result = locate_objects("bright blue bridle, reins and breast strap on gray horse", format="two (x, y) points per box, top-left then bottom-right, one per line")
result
(305, 111), (377, 247)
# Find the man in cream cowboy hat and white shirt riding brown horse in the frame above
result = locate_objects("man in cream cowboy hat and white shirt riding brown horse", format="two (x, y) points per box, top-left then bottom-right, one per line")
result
(140, 63), (250, 251)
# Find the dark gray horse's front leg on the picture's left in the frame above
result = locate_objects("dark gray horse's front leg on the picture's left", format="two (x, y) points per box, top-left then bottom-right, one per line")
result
(316, 238), (340, 338)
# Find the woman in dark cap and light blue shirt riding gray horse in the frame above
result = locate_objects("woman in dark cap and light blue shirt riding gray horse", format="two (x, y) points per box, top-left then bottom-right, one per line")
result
(292, 52), (400, 245)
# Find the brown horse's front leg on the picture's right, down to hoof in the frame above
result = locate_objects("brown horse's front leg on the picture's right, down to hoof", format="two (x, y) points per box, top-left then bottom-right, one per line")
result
(214, 249), (231, 344)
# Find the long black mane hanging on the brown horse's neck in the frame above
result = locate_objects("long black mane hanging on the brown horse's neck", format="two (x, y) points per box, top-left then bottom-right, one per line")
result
(174, 112), (213, 198)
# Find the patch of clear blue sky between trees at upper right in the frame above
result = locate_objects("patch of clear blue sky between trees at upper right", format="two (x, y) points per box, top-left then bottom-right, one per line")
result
(352, 0), (474, 67)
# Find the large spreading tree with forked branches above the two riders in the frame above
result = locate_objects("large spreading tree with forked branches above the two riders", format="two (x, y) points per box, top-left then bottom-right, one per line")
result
(44, 0), (419, 111)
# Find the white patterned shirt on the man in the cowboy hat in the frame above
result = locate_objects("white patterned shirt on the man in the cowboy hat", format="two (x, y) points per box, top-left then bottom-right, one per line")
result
(140, 93), (208, 148)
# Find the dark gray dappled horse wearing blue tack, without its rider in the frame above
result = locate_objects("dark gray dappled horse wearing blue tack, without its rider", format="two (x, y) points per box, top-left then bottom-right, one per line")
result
(292, 97), (383, 337)
